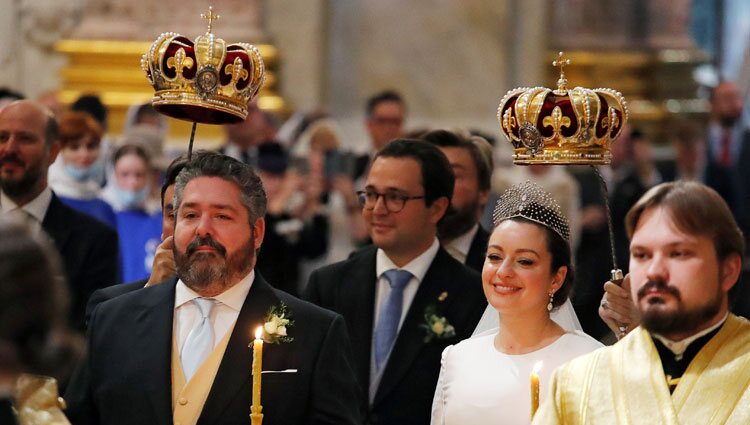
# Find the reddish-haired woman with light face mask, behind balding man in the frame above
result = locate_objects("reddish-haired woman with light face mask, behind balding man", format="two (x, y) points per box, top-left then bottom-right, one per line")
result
(49, 112), (117, 227)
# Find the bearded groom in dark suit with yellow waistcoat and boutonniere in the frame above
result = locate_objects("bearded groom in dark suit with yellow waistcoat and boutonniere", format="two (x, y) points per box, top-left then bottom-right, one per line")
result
(66, 154), (361, 425)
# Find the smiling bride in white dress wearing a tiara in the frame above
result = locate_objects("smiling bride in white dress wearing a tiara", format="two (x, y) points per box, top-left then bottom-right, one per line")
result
(432, 182), (601, 424)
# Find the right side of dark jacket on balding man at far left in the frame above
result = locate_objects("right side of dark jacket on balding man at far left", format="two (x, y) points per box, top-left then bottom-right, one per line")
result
(42, 194), (118, 330)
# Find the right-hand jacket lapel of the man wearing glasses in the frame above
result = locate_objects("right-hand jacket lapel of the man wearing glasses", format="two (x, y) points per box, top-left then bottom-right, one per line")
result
(373, 248), (461, 405)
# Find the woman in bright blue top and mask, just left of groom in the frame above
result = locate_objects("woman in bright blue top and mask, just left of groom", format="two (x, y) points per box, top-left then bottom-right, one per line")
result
(103, 144), (162, 282)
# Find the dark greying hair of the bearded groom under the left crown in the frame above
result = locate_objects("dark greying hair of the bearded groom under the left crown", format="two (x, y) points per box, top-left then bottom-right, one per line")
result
(174, 152), (267, 222)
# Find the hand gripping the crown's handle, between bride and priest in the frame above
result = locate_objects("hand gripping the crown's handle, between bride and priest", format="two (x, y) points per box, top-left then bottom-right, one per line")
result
(599, 275), (641, 339)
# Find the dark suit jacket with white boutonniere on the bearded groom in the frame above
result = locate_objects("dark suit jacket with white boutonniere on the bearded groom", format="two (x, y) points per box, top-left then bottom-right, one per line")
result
(65, 273), (361, 425)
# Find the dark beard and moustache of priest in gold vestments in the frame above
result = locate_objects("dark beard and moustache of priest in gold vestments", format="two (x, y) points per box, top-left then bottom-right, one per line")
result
(637, 281), (724, 335)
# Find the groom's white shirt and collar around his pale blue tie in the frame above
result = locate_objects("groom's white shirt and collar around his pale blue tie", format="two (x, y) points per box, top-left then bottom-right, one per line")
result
(173, 270), (255, 356)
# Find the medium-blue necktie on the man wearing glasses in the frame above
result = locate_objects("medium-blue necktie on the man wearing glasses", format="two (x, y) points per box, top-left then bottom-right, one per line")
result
(375, 269), (412, 370)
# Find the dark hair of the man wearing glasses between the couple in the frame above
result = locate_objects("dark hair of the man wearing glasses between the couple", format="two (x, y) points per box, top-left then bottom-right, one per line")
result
(373, 139), (455, 206)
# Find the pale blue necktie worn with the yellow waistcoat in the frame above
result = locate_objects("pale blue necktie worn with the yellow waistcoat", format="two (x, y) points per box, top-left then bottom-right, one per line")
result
(180, 298), (215, 382)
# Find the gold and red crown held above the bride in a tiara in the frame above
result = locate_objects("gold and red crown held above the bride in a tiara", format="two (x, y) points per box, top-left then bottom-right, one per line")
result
(497, 52), (628, 165)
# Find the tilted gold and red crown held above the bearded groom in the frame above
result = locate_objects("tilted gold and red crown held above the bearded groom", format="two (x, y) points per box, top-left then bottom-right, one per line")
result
(141, 7), (265, 124)
